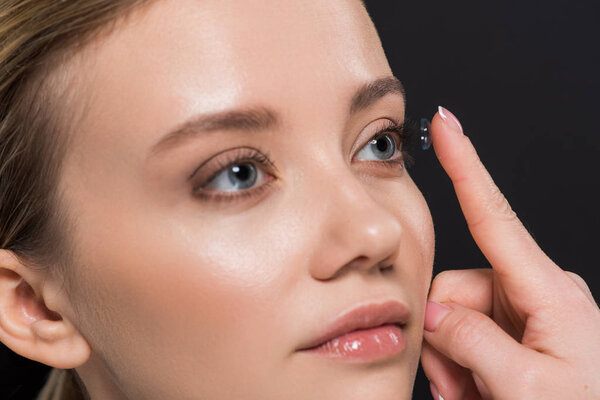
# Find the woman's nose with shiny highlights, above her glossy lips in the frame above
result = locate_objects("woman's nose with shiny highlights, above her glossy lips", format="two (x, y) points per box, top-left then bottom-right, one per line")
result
(309, 164), (402, 280)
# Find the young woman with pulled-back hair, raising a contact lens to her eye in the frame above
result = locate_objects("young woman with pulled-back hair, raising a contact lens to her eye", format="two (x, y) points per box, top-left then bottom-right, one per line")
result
(0, 0), (600, 400)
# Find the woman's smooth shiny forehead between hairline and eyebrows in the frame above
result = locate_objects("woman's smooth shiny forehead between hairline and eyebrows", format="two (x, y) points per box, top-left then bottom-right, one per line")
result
(63, 0), (391, 166)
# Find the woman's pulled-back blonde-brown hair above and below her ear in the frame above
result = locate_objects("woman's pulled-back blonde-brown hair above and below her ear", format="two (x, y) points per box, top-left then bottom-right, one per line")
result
(0, 0), (148, 399)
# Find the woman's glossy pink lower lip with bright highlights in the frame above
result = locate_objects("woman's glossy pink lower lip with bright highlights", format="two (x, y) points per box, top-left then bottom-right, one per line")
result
(302, 324), (406, 362)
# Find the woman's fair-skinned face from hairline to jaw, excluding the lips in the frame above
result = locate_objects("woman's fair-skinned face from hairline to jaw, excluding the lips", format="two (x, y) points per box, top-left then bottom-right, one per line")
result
(60, 0), (434, 400)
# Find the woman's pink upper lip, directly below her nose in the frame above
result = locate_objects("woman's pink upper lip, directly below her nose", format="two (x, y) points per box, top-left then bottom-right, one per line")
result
(298, 300), (410, 350)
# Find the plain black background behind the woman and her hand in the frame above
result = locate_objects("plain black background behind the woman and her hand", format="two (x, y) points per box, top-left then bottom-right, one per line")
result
(0, 0), (600, 399)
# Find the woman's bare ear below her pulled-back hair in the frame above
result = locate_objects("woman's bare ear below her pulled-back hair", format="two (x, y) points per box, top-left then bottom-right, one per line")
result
(0, 249), (91, 369)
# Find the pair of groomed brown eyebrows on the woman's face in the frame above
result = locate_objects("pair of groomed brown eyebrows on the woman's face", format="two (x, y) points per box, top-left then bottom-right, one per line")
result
(150, 76), (406, 155)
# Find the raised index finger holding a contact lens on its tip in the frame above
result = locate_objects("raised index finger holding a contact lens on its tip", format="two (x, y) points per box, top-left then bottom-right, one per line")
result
(431, 107), (564, 304)
